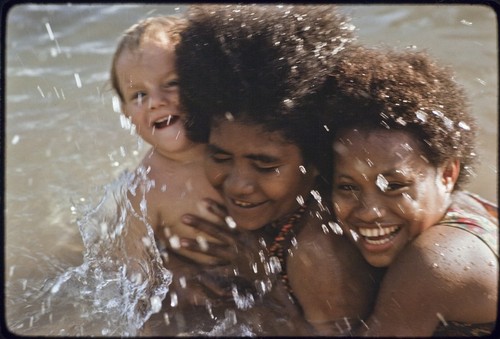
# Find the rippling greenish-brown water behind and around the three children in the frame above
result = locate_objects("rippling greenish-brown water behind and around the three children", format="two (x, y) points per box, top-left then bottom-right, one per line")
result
(4, 4), (498, 336)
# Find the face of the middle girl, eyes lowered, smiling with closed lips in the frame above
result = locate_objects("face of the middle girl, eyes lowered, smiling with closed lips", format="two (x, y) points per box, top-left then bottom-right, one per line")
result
(205, 120), (317, 230)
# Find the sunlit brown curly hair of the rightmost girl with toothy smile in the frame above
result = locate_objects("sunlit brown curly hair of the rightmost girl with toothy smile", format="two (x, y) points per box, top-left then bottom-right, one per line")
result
(325, 45), (477, 189)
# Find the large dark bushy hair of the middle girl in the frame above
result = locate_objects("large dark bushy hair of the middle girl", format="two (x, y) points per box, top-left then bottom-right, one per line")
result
(176, 5), (353, 183)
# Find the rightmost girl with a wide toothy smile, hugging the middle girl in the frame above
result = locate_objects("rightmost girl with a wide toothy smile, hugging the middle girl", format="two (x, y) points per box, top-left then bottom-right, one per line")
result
(329, 48), (498, 337)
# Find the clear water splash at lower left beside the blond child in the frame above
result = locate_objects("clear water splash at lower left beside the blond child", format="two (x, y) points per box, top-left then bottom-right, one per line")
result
(7, 172), (171, 336)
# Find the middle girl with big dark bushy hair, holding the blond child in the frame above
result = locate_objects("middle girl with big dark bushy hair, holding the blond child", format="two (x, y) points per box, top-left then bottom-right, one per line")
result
(177, 5), (376, 336)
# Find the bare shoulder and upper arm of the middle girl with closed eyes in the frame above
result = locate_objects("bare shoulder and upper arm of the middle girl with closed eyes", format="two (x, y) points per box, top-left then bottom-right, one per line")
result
(287, 219), (378, 335)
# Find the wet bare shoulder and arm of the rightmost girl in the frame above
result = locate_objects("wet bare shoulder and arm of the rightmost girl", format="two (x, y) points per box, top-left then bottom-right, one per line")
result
(364, 226), (498, 336)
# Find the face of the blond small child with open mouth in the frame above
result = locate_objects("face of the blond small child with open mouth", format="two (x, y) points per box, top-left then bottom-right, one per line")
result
(116, 41), (196, 156)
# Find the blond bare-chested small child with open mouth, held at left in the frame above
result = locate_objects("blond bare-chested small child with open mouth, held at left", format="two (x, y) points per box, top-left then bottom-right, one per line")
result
(111, 17), (227, 322)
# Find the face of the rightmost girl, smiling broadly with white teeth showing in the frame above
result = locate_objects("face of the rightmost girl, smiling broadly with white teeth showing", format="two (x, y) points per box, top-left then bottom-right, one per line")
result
(332, 129), (458, 267)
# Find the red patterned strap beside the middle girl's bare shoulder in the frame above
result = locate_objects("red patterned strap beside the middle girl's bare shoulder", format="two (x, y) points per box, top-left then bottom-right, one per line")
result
(269, 205), (307, 296)
